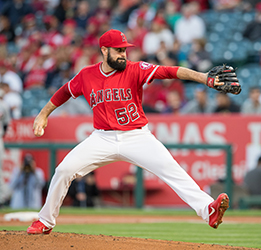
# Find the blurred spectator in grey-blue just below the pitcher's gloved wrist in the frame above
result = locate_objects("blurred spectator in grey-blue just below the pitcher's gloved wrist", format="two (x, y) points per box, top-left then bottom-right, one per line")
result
(180, 86), (215, 114)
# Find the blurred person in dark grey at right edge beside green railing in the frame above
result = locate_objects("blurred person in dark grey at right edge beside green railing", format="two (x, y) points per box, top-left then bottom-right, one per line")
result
(244, 156), (261, 195)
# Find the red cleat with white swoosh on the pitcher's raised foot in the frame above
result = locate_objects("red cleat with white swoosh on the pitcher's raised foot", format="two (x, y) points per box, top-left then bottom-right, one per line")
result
(208, 193), (229, 228)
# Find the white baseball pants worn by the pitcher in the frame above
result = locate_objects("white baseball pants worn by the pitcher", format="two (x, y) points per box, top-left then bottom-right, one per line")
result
(39, 125), (214, 228)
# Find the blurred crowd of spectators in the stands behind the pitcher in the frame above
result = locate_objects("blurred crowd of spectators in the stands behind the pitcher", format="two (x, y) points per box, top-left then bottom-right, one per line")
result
(0, 0), (261, 119)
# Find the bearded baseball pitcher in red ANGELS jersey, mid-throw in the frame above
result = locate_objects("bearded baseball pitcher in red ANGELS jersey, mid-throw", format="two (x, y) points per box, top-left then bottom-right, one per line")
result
(27, 30), (241, 234)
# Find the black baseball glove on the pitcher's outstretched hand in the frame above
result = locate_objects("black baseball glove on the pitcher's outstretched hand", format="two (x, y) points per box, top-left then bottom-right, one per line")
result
(206, 65), (241, 95)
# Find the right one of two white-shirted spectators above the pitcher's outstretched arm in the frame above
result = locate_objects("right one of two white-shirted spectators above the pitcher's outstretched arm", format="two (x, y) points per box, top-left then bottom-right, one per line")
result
(174, 3), (206, 45)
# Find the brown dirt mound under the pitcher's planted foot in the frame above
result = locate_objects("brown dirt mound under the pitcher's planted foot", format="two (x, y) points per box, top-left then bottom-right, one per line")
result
(0, 230), (256, 250)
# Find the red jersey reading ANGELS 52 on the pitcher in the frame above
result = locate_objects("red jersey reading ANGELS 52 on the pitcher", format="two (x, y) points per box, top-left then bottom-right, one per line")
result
(68, 61), (159, 131)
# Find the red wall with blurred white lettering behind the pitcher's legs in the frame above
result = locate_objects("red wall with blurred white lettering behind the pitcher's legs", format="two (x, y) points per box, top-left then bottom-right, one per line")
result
(4, 115), (261, 206)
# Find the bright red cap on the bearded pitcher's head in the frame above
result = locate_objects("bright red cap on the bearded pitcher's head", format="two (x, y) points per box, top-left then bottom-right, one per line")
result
(99, 29), (135, 48)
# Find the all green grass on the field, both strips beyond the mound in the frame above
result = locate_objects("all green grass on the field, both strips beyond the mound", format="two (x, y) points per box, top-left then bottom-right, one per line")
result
(0, 208), (261, 249)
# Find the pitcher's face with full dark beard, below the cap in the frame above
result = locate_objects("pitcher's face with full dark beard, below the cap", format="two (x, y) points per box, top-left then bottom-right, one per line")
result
(107, 48), (127, 70)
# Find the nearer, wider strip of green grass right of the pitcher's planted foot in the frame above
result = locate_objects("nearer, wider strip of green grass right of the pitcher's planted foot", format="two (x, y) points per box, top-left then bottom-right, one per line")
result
(56, 223), (261, 248)
